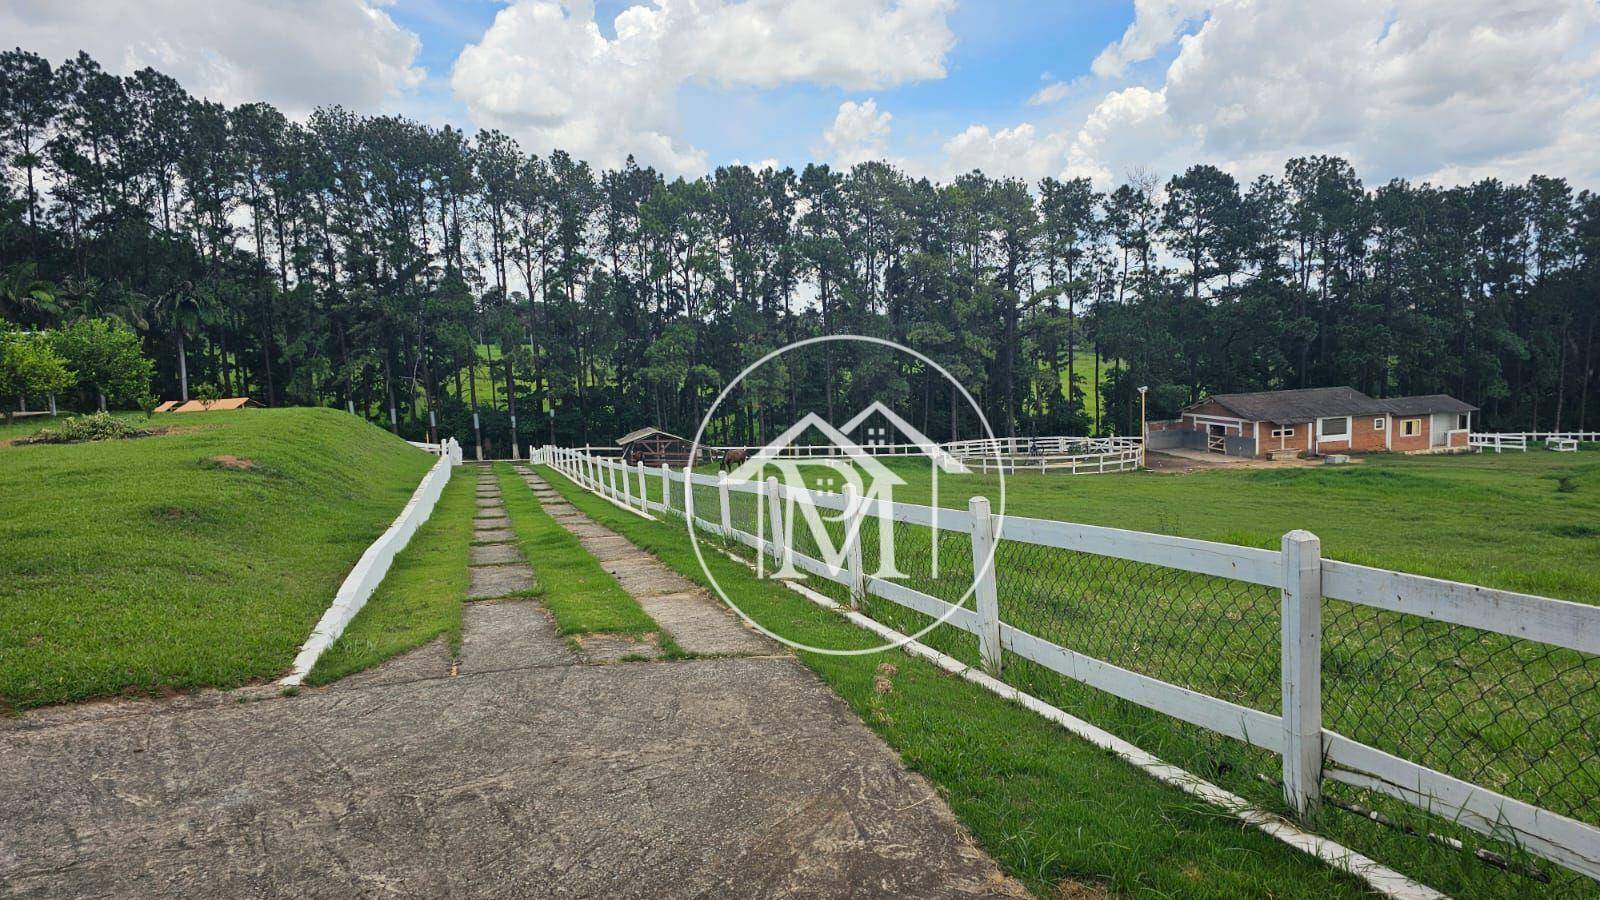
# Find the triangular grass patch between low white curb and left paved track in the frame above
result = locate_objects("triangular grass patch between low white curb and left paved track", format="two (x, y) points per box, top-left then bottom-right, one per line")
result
(306, 469), (475, 685)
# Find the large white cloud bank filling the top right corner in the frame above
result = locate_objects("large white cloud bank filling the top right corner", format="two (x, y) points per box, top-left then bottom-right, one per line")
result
(944, 0), (1600, 186)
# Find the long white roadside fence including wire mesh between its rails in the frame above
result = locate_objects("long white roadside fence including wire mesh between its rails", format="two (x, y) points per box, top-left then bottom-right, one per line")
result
(536, 447), (1600, 879)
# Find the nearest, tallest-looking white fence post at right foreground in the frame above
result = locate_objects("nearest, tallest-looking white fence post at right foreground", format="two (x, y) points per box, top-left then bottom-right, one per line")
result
(1282, 530), (1322, 818)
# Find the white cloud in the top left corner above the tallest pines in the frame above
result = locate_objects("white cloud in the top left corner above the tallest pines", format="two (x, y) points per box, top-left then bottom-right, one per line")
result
(0, 0), (424, 115)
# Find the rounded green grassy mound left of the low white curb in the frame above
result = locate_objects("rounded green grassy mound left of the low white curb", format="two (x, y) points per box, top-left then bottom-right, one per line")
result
(0, 408), (432, 711)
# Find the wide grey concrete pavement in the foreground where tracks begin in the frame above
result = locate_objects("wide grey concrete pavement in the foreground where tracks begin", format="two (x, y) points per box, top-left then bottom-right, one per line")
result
(0, 469), (1019, 897)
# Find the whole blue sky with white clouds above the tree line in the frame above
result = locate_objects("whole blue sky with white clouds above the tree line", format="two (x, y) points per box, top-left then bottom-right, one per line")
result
(0, 0), (1600, 189)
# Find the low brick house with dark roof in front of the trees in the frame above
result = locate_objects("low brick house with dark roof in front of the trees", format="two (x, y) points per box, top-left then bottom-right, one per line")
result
(1149, 388), (1477, 458)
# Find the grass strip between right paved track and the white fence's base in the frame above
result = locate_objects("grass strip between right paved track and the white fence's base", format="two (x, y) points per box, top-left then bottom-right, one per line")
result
(541, 469), (1362, 897)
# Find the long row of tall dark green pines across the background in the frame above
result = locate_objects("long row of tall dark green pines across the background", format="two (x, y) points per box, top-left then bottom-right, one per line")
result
(0, 50), (1600, 450)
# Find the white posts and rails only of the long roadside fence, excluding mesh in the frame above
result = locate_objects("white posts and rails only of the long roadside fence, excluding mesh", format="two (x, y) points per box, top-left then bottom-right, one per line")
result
(534, 447), (1600, 879)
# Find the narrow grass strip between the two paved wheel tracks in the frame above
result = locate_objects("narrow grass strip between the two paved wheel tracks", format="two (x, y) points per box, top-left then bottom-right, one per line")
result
(494, 463), (666, 639)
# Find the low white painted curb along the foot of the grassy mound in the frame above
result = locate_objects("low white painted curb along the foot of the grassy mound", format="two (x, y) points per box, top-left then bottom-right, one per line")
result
(278, 439), (461, 687)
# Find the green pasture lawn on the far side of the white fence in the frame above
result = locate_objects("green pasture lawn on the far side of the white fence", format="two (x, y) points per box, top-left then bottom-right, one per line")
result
(552, 453), (1600, 895)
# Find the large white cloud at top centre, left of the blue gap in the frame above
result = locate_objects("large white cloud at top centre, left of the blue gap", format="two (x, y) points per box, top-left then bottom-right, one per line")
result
(451, 0), (955, 175)
